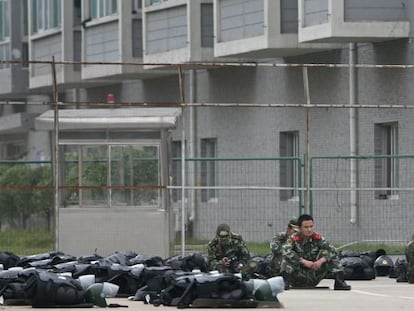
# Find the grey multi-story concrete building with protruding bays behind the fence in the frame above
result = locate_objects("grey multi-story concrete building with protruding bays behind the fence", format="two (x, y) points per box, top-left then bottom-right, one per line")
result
(0, 0), (414, 254)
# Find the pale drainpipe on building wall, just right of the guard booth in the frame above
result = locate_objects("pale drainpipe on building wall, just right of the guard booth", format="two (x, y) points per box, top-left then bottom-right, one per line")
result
(188, 69), (197, 234)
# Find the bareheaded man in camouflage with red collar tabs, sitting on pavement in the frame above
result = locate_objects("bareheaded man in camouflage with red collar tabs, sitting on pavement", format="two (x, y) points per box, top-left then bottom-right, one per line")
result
(282, 214), (351, 290)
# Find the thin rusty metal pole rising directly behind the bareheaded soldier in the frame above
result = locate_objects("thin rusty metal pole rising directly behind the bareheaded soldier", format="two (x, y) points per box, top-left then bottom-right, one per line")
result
(302, 66), (311, 213)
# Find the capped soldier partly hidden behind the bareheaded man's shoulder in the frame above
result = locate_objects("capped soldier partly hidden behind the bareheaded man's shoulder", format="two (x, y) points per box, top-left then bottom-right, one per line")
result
(270, 218), (299, 276)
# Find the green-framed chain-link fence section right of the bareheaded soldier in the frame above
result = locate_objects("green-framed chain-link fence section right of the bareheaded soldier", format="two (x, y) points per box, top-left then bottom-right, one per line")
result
(310, 155), (414, 250)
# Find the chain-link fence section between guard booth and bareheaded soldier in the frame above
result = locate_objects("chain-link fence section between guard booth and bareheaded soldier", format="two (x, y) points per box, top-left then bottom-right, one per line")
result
(172, 157), (303, 242)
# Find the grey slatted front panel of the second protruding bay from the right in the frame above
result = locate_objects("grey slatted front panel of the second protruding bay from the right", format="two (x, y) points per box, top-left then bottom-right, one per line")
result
(218, 0), (264, 42)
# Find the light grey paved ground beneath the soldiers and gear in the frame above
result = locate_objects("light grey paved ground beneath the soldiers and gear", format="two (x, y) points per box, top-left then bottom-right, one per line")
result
(0, 277), (414, 311)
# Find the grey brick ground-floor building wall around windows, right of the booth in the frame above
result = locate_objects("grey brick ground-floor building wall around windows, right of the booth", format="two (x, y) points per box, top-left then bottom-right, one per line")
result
(158, 40), (414, 243)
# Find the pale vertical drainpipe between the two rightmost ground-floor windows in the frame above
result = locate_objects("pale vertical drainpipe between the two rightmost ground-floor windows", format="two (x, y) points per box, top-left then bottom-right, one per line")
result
(349, 43), (358, 224)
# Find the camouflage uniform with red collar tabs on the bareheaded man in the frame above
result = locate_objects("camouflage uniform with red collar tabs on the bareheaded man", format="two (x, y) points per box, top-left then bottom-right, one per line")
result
(282, 232), (343, 287)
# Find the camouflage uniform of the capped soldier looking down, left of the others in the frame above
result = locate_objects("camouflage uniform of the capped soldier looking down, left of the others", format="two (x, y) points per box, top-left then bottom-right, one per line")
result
(207, 232), (250, 273)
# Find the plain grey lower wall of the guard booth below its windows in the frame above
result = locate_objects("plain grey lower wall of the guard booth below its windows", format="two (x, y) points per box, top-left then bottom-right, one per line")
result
(59, 208), (169, 258)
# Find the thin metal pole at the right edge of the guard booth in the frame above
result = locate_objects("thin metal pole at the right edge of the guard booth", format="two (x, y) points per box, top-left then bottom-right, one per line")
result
(178, 65), (186, 256)
